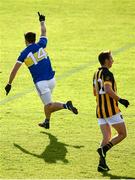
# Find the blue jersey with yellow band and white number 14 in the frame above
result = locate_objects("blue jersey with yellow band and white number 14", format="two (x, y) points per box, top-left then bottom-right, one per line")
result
(17, 37), (55, 83)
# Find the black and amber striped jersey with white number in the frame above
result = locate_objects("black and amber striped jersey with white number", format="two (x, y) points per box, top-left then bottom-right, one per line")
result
(93, 67), (120, 118)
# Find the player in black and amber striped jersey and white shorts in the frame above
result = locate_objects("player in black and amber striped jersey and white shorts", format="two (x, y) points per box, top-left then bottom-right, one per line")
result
(93, 51), (129, 171)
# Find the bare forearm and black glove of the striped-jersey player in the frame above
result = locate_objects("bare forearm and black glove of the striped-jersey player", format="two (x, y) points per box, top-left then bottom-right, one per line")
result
(104, 83), (129, 108)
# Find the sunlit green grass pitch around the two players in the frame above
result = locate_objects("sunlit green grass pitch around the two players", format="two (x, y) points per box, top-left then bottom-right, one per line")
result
(0, 0), (135, 179)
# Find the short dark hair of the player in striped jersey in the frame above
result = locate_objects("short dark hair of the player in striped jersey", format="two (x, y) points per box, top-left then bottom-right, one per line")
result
(98, 51), (111, 65)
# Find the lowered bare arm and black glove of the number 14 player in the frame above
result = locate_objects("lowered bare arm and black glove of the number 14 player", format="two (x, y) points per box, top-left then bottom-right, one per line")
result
(5, 62), (22, 95)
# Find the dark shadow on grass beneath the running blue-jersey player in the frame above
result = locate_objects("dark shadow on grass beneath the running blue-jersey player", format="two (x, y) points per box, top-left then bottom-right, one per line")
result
(14, 132), (84, 163)
